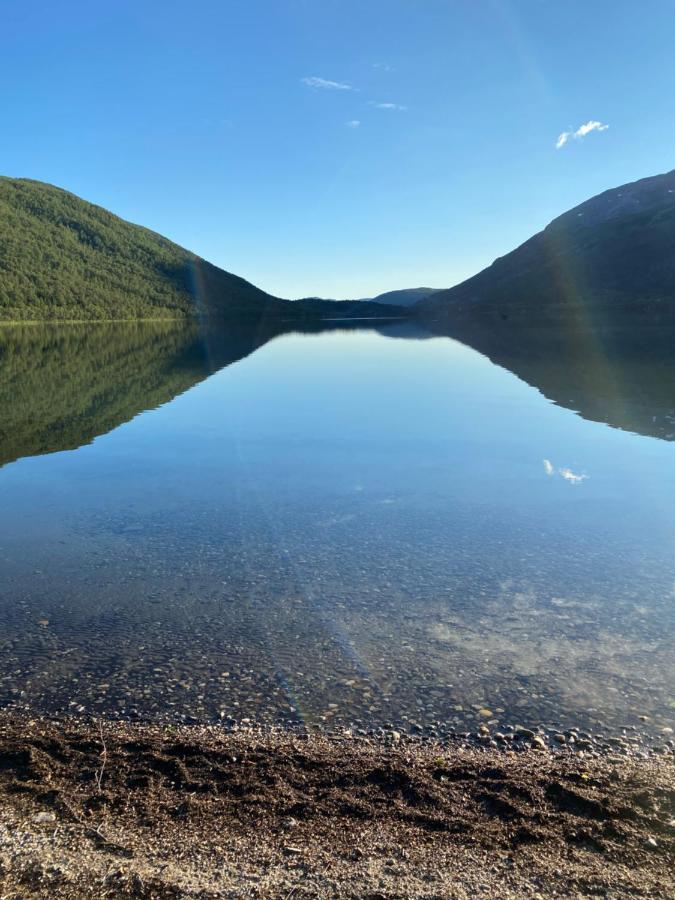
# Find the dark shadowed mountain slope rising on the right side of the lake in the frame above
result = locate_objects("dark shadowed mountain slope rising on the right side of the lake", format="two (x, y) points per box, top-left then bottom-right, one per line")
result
(422, 171), (675, 326)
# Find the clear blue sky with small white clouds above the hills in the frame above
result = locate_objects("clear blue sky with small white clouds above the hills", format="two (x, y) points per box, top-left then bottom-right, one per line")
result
(0, 0), (675, 297)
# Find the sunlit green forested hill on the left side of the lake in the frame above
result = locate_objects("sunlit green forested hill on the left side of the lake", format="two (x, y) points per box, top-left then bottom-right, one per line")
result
(0, 177), (290, 320)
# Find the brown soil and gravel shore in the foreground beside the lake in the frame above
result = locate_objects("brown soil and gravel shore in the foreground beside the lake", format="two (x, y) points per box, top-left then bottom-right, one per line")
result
(0, 716), (675, 900)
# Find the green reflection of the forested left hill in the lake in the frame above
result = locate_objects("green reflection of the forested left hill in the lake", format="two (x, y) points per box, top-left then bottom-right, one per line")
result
(0, 321), (434, 466)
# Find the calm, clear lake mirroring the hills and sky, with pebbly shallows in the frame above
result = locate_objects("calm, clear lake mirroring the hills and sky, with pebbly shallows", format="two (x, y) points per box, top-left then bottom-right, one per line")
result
(0, 322), (675, 730)
